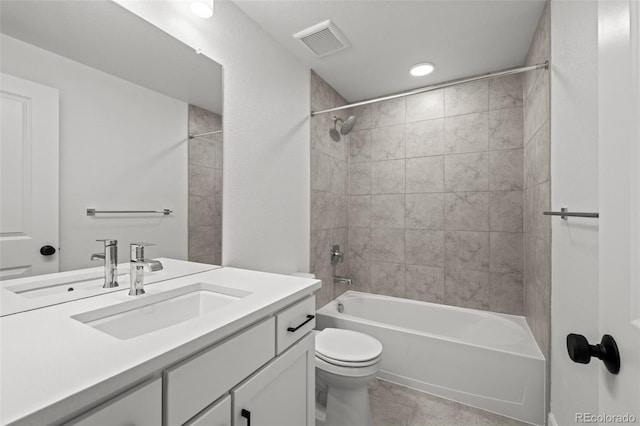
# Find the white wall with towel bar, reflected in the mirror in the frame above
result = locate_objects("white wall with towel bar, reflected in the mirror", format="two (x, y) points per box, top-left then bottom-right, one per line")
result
(1, 35), (187, 271)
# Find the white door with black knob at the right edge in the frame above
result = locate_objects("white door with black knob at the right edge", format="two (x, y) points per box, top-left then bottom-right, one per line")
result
(592, 0), (640, 424)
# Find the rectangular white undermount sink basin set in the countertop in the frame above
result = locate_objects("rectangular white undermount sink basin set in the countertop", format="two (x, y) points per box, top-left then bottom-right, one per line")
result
(71, 283), (251, 340)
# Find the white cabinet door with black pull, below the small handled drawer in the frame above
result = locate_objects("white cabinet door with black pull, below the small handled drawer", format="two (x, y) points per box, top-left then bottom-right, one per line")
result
(231, 333), (315, 426)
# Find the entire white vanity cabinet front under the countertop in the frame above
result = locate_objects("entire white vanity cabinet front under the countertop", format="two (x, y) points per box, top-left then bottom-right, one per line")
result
(35, 296), (315, 426)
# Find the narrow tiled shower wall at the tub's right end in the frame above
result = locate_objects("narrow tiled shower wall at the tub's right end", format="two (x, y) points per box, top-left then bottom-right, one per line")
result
(524, 2), (551, 359)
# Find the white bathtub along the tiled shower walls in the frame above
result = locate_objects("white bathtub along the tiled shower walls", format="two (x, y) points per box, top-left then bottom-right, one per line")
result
(316, 291), (545, 425)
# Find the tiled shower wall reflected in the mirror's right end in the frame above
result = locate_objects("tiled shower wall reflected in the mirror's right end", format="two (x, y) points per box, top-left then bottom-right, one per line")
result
(188, 105), (222, 265)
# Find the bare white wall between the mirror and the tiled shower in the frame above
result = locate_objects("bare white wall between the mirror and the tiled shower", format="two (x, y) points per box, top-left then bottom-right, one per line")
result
(115, 0), (310, 273)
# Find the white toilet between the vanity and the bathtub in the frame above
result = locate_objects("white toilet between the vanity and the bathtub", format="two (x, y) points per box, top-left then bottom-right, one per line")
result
(315, 328), (382, 426)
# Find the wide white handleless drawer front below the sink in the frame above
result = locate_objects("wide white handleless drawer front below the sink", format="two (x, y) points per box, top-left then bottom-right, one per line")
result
(163, 318), (275, 426)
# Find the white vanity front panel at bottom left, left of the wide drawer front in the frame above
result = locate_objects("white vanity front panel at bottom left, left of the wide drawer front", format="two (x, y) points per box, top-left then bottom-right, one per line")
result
(65, 379), (162, 426)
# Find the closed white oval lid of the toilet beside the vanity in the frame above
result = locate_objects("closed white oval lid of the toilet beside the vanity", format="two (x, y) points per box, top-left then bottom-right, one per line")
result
(316, 328), (382, 363)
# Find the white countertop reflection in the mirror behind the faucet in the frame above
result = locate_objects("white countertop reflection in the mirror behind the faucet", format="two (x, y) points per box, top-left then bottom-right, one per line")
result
(0, 257), (220, 316)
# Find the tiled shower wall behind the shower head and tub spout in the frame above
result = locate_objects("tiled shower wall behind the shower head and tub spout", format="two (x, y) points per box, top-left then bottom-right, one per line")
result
(311, 72), (349, 308)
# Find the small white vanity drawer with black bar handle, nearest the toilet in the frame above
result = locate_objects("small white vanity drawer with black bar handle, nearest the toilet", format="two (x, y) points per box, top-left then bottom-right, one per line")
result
(276, 296), (316, 354)
